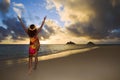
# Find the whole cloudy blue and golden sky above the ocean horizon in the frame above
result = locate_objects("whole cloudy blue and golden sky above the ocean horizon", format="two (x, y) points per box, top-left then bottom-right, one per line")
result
(0, 0), (120, 44)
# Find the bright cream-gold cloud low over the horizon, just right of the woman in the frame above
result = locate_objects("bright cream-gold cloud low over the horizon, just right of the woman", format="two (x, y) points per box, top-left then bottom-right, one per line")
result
(40, 19), (86, 44)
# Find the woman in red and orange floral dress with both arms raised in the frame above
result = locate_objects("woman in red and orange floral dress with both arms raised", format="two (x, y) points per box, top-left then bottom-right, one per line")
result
(18, 16), (46, 73)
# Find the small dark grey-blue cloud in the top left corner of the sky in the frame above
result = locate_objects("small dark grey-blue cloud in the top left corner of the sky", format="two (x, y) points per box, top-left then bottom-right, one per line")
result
(0, 0), (10, 13)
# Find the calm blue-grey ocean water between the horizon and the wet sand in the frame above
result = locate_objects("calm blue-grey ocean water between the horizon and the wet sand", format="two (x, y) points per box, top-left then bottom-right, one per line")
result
(0, 44), (88, 60)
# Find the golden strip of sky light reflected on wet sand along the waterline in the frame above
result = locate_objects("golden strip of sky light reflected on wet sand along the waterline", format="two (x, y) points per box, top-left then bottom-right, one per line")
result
(5, 47), (99, 65)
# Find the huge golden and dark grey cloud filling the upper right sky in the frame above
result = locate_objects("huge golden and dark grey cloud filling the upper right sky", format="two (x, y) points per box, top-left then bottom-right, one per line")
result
(46, 0), (120, 40)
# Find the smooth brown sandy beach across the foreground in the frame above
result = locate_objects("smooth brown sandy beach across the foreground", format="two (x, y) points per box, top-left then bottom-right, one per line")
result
(0, 46), (120, 80)
